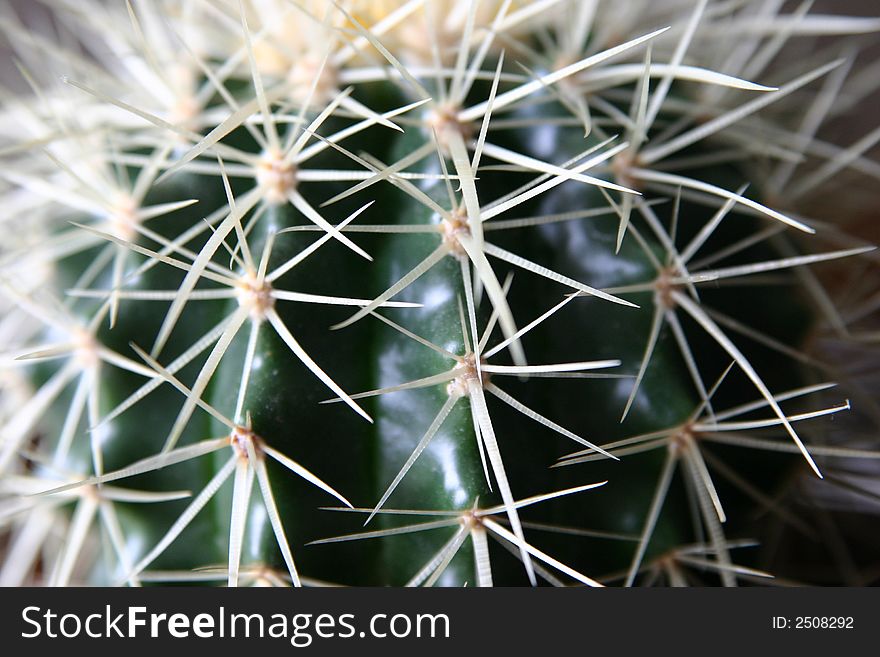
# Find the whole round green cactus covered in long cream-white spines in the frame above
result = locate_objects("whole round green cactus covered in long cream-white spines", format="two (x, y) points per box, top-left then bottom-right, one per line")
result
(0, 0), (880, 586)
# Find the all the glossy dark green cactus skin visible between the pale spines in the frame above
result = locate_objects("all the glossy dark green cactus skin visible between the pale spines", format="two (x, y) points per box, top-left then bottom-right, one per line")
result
(39, 77), (807, 585)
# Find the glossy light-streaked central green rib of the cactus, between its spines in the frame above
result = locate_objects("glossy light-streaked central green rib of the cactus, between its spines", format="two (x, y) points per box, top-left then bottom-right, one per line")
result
(366, 129), (489, 586)
